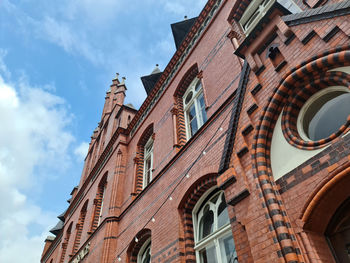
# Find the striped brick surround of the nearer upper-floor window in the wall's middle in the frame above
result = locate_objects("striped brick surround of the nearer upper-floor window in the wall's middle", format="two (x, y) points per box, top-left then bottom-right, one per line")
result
(174, 64), (198, 146)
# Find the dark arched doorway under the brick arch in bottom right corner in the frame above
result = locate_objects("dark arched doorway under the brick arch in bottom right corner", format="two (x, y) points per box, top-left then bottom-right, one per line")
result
(325, 198), (350, 263)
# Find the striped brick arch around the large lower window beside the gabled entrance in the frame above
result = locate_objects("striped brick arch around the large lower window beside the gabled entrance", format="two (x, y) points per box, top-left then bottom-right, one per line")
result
(179, 174), (217, 263)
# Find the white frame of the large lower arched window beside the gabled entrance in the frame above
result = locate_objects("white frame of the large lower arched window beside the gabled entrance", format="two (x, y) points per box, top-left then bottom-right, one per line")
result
(192, 190), (237, 263)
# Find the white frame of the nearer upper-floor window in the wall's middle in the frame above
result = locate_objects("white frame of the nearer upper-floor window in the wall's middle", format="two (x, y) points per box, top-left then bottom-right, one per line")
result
(182, 78), (207, 140)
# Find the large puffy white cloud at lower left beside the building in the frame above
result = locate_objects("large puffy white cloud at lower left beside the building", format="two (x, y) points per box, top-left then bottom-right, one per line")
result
(0, 58), (78, 263)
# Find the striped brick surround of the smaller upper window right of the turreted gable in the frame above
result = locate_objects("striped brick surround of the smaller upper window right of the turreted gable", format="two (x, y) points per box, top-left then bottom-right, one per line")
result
(135, 123), (155, 193)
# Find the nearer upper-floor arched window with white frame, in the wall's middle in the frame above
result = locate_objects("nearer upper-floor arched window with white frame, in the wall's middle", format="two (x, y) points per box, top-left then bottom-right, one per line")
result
(183, 78), (207, 139)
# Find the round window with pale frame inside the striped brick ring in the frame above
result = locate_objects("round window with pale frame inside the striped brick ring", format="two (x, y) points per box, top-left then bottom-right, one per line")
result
(299, 87), (350, 141)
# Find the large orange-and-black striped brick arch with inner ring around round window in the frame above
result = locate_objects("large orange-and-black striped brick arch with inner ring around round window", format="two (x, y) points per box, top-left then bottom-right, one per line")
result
(252, 46), (350, 262)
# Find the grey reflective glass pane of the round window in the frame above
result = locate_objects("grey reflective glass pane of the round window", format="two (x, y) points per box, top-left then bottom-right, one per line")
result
(307, 93), (350, 141)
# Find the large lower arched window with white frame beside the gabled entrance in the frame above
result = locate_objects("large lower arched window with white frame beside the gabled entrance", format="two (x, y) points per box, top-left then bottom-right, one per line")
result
(193, 190), (238, 263)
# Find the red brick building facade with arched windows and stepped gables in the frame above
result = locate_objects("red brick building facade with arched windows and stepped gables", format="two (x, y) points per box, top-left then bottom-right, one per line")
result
(41, 0), (350, 263)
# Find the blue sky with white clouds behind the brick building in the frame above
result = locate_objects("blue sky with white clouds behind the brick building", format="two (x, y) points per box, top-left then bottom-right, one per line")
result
(0, 0), (206, 263)
